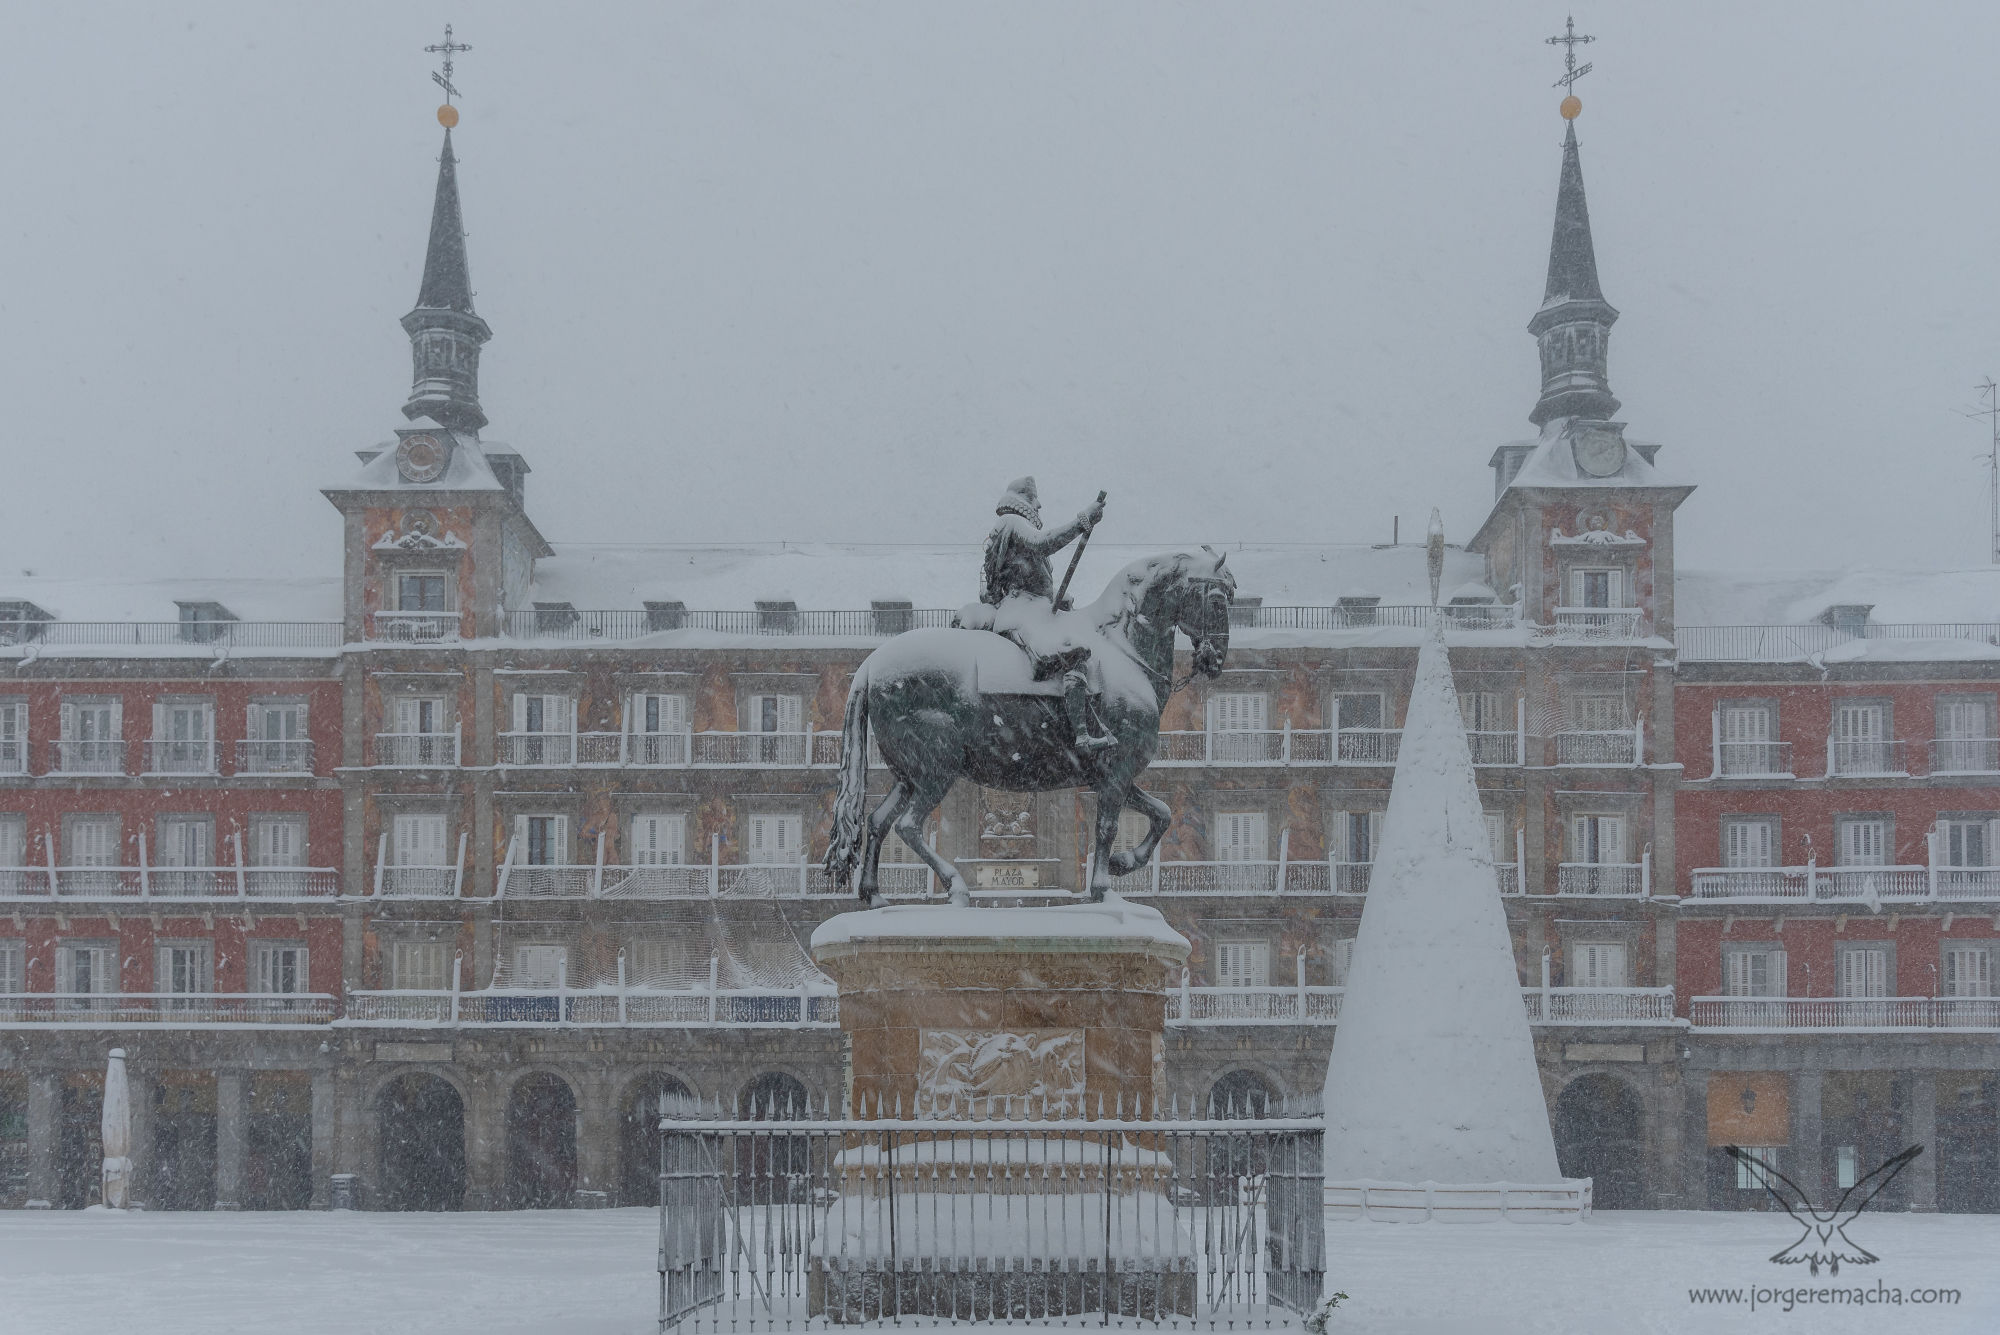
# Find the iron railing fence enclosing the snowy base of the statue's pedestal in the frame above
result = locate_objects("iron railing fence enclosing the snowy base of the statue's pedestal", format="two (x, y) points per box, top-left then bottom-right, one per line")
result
(658, 1101), (1326, 1335)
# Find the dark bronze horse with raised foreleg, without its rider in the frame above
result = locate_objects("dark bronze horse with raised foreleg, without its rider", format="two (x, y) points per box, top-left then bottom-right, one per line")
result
(826, 548), (1236, 903)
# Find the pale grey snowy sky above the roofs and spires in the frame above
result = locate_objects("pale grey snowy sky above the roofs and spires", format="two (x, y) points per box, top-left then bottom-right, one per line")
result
(0, 0), (2000, 594)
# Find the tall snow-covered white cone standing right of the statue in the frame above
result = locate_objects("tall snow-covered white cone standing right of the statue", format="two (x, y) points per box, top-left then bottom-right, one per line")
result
(1326, 630), (1560, 1185)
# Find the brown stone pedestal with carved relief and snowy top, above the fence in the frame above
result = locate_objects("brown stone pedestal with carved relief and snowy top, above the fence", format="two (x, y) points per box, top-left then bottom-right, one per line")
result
(812, 897), (1188, 1119)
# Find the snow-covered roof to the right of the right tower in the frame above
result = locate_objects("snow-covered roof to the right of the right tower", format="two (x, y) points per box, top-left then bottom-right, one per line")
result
(1674, 566), (2000, 626)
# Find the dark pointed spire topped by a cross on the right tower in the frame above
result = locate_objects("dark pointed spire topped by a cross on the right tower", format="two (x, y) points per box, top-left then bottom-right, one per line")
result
(1528, 24), (1618, 426)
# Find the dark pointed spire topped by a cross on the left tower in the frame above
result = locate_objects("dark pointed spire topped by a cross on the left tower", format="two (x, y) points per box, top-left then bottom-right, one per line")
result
(402, 28), (492, 432)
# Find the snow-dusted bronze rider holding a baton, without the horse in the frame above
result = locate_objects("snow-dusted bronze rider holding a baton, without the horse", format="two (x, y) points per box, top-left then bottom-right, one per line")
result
(980, 478), (1118, 755)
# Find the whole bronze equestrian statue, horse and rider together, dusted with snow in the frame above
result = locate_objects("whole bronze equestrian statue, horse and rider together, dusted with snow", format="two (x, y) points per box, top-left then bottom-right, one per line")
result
(826, 478), (1236, 903)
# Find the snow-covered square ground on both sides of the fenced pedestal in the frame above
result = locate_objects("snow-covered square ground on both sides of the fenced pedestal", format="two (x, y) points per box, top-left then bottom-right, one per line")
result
(0, 1209), (2000, 1335)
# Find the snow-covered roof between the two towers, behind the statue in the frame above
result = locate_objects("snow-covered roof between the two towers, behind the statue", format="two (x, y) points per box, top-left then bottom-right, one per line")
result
(532, 542), (1486, 610)
